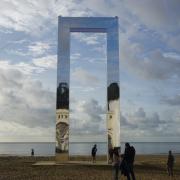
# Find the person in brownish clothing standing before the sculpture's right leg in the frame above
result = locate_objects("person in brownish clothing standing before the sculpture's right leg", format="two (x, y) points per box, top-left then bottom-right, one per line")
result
(113, 148), (120, 180)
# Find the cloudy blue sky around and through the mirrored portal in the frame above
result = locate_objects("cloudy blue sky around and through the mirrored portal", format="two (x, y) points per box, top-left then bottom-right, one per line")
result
(0, 0), (180, 141)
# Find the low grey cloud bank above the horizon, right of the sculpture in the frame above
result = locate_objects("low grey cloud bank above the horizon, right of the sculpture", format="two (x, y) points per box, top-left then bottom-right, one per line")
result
(121, 108), (180, 142)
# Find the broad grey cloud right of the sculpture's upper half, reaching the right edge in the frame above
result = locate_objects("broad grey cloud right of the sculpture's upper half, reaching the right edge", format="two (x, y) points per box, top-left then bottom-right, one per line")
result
(120, 38), (180, 80)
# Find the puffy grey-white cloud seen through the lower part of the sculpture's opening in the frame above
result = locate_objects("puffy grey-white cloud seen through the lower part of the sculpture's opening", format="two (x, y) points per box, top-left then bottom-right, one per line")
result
(70, 99), (106, 134)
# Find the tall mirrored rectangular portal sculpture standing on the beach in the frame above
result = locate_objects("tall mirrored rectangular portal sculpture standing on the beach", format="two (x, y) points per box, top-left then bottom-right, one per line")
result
(56, 16), (120, 162)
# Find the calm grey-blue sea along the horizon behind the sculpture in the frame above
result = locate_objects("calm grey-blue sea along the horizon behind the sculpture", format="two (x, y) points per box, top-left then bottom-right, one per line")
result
(0, 142), (180, 156)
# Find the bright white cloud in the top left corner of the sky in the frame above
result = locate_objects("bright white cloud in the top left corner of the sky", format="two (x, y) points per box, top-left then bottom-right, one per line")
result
(0, 1), (48, 34)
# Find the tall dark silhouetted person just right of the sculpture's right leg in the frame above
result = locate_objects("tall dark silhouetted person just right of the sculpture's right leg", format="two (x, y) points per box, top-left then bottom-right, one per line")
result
(123, 143), (136, 180)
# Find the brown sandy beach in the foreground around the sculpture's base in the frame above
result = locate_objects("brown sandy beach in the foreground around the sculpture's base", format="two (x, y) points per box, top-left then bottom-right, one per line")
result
(0, 155), (180, 180)
